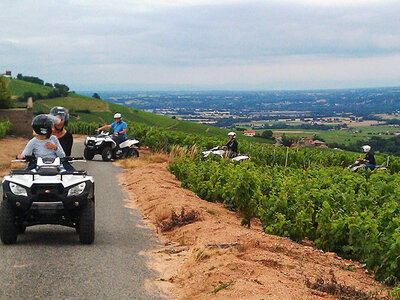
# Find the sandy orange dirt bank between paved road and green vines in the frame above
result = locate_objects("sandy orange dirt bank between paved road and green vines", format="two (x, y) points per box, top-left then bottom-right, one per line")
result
(118, 151), (389, 299)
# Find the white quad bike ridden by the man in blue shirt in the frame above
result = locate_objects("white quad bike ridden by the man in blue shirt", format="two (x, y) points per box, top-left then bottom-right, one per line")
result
(83, 131), (140, 161)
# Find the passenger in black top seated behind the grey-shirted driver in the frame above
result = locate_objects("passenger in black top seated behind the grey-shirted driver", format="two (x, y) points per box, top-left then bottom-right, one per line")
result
(50, 106), (74, 156)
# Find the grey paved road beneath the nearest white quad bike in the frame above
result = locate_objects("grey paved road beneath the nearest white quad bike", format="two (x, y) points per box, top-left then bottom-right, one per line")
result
(0, 141), (163, 299)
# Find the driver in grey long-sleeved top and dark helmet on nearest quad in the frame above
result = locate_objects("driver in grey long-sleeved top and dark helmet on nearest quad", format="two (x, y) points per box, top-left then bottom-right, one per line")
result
(18, 114), (65, 170)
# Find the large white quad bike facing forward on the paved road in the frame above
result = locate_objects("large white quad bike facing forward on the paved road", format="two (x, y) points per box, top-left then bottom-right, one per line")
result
(0, 156), (95, 244)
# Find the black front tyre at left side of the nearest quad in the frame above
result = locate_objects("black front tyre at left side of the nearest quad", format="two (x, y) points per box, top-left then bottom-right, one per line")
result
(0, 199), (18, 245)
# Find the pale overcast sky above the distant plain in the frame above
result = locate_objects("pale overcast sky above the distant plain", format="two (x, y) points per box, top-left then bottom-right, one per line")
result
(0, 0), (400, 91)
